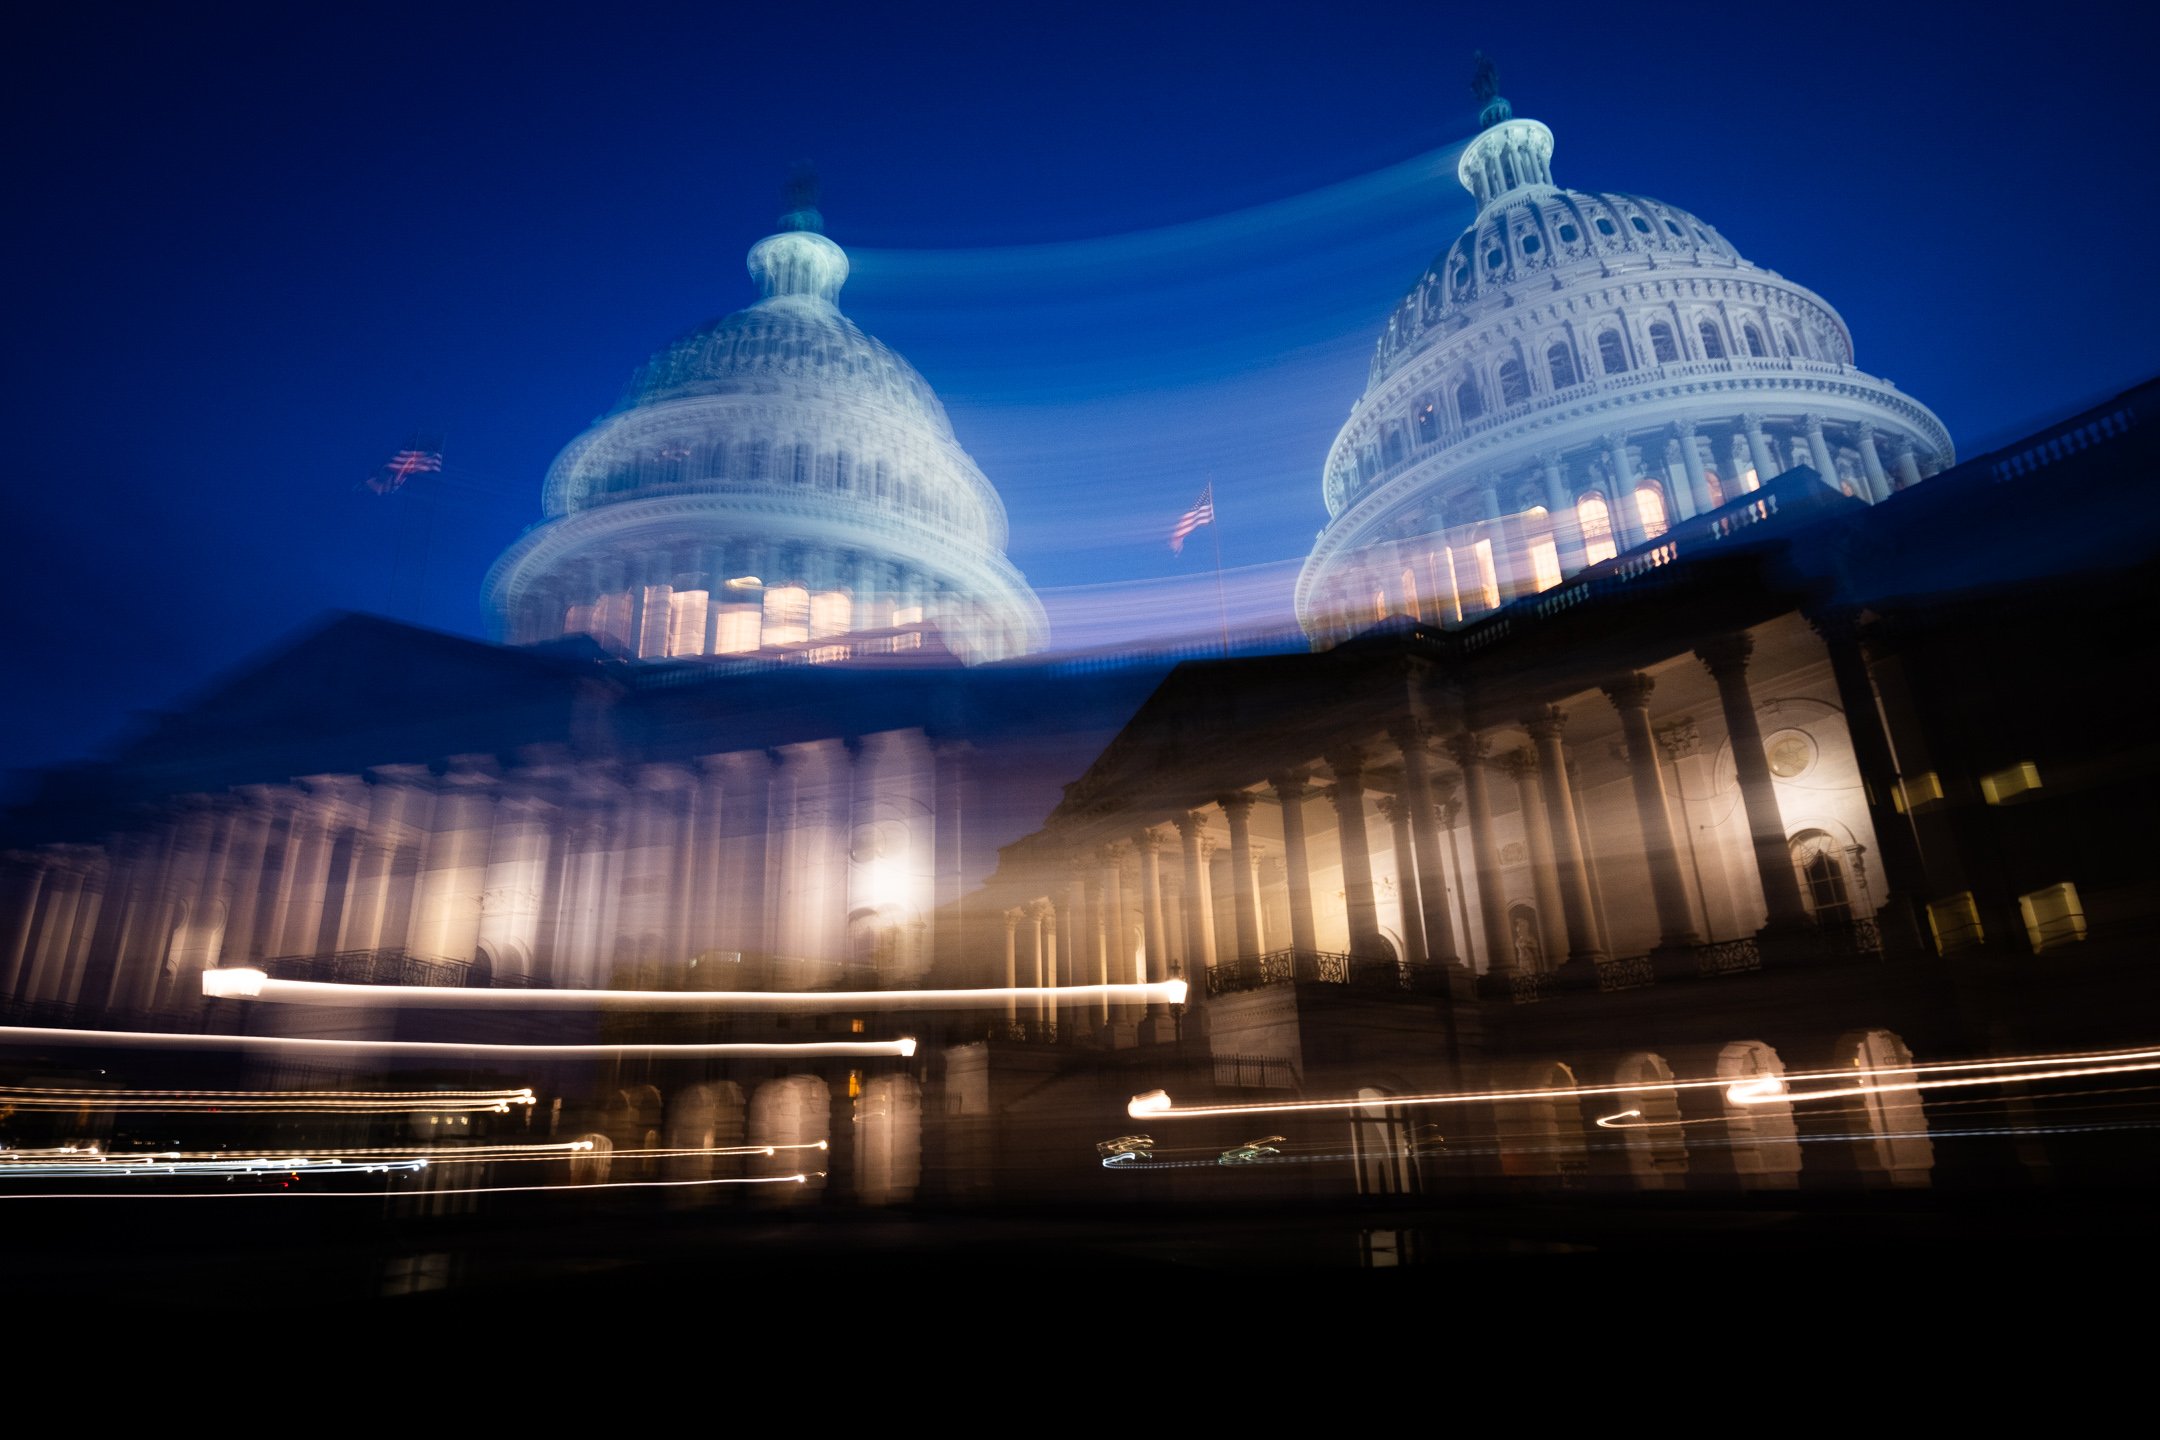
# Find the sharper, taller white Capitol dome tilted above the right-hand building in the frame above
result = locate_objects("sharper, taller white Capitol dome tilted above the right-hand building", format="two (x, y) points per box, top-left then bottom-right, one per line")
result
(1296, 63), (1955, 641)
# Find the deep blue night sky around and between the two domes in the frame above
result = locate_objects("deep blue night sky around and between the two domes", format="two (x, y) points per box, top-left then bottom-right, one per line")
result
(0, 2), (2160, 790)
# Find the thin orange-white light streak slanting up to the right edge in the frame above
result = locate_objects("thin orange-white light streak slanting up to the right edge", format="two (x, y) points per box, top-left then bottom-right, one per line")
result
(1125, 1049), (2160, 1120)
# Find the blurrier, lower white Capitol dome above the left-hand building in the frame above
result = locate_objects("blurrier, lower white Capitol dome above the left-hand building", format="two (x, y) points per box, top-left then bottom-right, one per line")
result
(486, 188), (1062, 661)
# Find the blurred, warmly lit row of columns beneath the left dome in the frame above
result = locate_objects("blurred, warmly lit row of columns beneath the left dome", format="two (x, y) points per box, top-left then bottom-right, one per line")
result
(0, 732), (966, 1010)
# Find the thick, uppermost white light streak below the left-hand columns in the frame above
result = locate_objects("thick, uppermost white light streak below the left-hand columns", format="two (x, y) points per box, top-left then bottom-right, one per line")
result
(203, 967), (1186, 1010)
